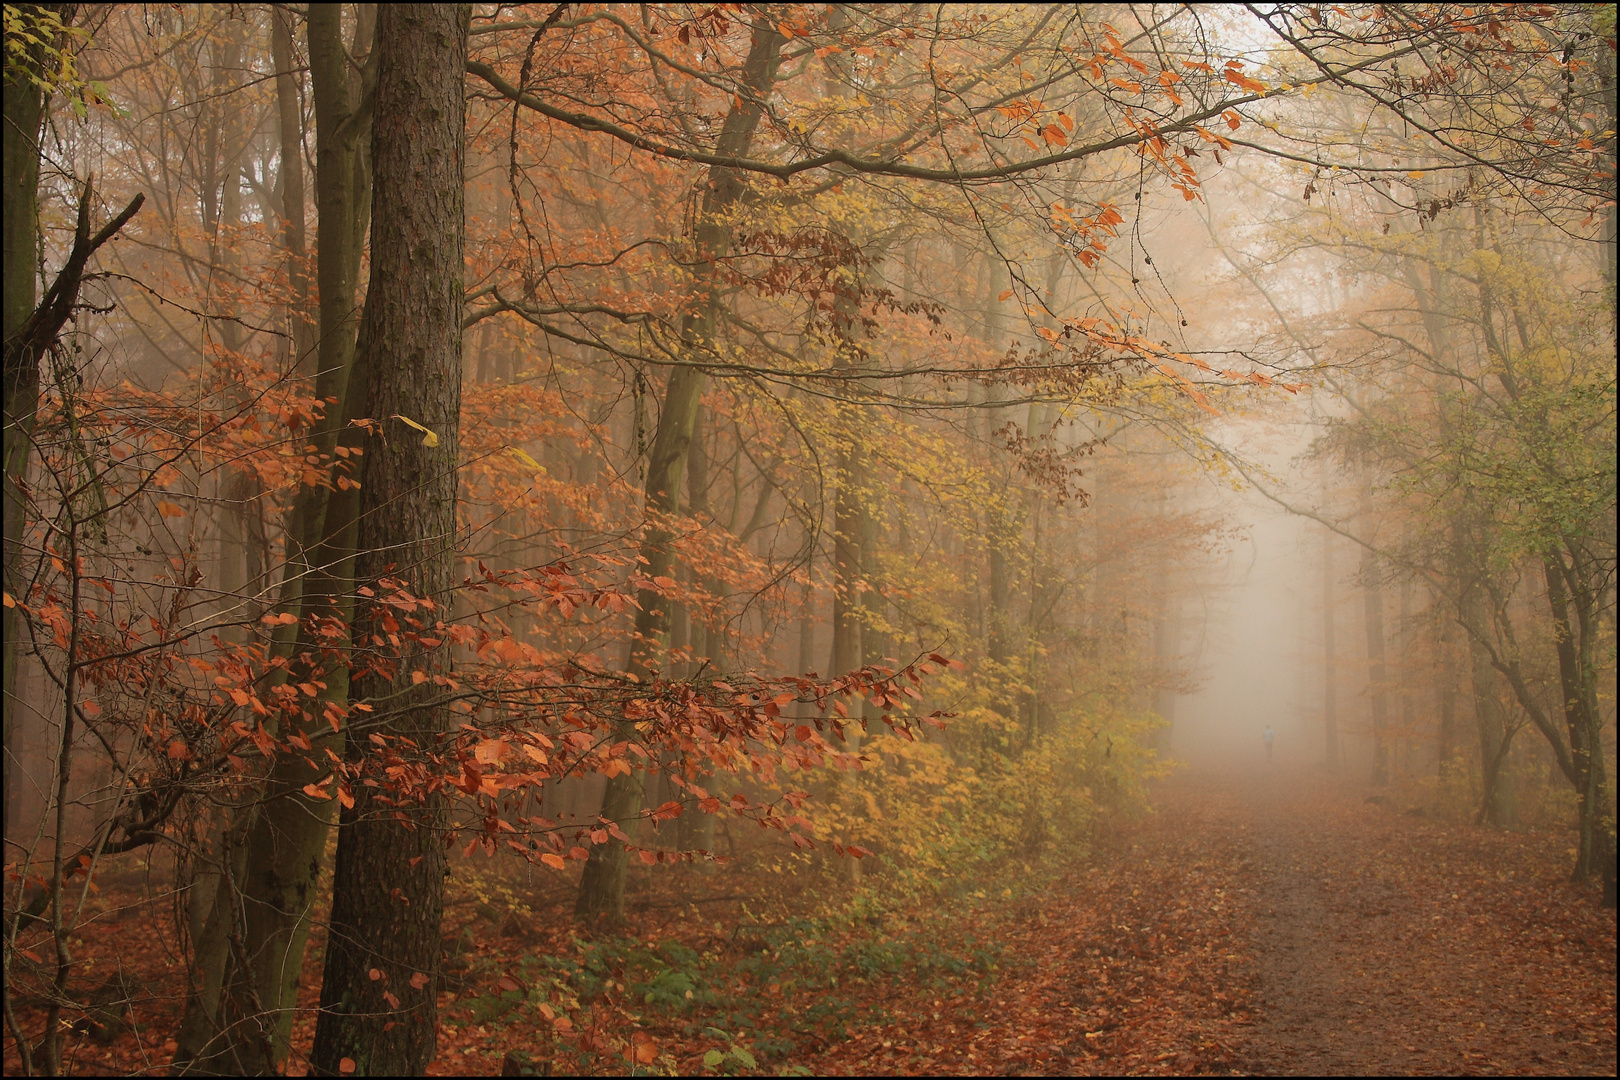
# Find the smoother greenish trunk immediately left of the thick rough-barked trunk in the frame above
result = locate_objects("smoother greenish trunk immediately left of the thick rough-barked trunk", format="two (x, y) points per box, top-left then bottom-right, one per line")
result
(173, 5), (376, 1074)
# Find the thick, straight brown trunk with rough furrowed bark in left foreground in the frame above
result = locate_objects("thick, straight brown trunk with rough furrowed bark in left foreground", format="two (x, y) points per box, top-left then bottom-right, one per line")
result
(311, 5), (471, 1077)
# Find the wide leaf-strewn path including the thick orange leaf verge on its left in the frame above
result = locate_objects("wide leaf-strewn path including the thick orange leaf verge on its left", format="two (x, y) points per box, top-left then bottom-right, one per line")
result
(822, 763), (1615, 1075)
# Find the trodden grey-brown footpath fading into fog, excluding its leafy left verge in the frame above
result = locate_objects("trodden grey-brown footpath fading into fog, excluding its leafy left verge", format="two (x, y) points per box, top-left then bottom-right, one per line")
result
(1231, 769), (1615, 1075)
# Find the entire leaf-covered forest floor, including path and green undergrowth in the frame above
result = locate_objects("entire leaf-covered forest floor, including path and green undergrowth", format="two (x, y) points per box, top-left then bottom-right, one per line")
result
(5, 766), (1615, 1075)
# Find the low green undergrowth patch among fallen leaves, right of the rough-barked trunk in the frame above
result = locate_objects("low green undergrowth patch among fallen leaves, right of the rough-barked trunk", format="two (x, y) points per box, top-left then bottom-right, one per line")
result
(458, 908), (1008, 1075)
